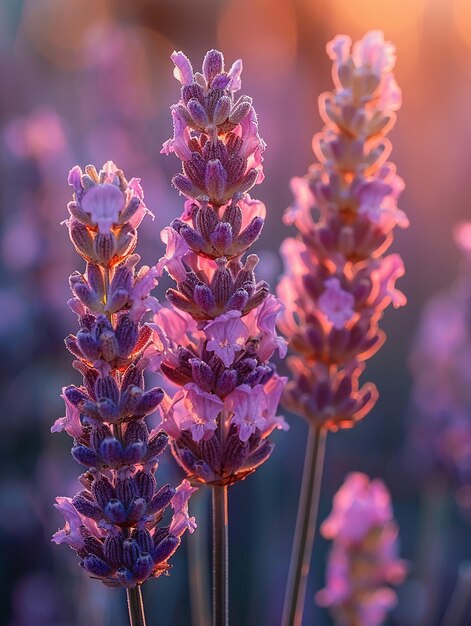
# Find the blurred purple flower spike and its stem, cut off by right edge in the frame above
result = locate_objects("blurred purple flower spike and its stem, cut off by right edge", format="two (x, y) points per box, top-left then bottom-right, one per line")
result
(401, 229), (471, 624)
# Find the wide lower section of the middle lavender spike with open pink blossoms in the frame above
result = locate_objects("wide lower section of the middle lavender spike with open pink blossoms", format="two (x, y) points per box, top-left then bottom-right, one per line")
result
(151, 299), (287, 482)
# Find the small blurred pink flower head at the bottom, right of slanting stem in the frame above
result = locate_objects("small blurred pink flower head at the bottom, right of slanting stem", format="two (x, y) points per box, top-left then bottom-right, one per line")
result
(316, 472), (406, 626)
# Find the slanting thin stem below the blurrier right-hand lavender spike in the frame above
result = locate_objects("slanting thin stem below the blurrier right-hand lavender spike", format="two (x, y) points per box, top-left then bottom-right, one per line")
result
(281, 426), (327, 626)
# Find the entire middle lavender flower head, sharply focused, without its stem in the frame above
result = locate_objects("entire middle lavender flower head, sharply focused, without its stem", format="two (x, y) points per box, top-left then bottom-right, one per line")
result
(155, 50), (286, 485)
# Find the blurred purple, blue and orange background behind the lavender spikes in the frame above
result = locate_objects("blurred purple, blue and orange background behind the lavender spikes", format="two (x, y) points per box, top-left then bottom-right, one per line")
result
(0, 0), (471, 626)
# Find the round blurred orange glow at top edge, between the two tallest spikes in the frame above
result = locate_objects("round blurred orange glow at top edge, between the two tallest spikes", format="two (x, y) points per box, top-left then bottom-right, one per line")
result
(218, 0), (297, 79)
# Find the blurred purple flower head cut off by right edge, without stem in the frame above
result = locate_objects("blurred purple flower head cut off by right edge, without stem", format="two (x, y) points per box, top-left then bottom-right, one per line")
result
(407, 223), (471, 513)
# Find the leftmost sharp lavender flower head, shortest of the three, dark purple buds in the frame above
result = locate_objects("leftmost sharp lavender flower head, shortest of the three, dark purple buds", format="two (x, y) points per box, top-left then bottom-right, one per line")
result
(52, 161), (195, 587)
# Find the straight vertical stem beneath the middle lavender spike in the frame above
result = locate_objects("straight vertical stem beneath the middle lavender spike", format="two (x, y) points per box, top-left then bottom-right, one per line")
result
(212, 485), (229, 626)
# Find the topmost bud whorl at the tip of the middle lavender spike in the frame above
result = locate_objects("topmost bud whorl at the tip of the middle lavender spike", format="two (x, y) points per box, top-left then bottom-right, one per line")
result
(162, 50), (265, 207)
